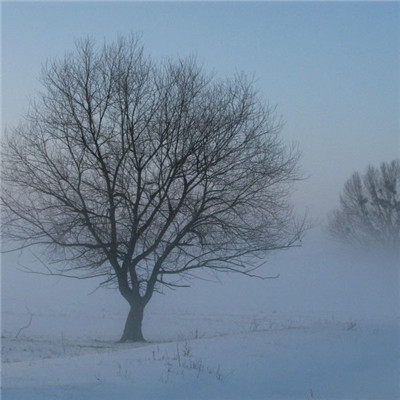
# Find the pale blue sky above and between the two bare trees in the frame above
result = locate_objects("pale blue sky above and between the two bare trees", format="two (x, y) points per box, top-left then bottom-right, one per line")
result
(2, 2), (400, 221)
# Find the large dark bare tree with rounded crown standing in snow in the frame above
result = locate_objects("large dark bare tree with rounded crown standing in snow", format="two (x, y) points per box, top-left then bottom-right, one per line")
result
(2, 36), (304, 341)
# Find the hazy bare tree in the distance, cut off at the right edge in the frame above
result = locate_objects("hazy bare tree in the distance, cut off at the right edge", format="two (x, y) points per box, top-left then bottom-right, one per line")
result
(329, 160), (400, 253)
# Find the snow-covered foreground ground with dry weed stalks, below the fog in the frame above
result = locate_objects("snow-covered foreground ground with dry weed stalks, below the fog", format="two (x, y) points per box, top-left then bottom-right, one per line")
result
(2, 315), (400, 400)
